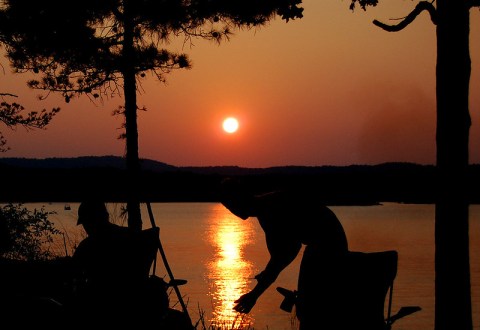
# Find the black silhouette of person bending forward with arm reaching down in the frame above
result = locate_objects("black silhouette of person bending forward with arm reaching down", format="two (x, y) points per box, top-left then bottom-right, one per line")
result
(220, 179), (348, 330)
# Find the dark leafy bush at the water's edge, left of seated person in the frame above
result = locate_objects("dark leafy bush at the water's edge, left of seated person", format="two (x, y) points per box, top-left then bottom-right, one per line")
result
(0, 203), (61, 261)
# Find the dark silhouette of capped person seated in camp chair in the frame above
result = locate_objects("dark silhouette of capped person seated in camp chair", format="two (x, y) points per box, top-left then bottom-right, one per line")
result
(73, 201), (158, 326)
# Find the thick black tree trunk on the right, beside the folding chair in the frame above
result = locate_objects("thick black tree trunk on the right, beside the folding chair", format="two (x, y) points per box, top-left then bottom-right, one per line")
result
(435, 0), (472, 330)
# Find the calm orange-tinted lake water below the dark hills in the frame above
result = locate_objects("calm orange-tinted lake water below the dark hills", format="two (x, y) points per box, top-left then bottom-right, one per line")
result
(31, 203), (480, 330)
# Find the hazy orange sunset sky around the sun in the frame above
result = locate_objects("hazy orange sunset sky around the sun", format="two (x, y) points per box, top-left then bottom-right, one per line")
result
(0, 0), (480, 168)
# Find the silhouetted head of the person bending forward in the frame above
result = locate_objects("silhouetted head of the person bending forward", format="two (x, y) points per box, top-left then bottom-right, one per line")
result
(220, 178), (254, 220)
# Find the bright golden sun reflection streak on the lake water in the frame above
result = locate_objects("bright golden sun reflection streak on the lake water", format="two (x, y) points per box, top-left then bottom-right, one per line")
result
(208, 205), (253, 329)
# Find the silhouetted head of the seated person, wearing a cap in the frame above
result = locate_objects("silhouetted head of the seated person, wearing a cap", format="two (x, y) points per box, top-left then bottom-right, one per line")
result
(77, 200), (109, 235)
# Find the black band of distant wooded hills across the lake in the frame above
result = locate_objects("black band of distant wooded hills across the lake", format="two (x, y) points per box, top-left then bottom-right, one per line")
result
(0, 156), (480, 205)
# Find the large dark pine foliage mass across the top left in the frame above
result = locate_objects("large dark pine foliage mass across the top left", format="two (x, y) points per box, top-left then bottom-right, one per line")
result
(0, 0), (303, 102)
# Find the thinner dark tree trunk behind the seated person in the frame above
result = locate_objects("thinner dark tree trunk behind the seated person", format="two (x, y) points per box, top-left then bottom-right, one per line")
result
(123, 0), (142, 231)
